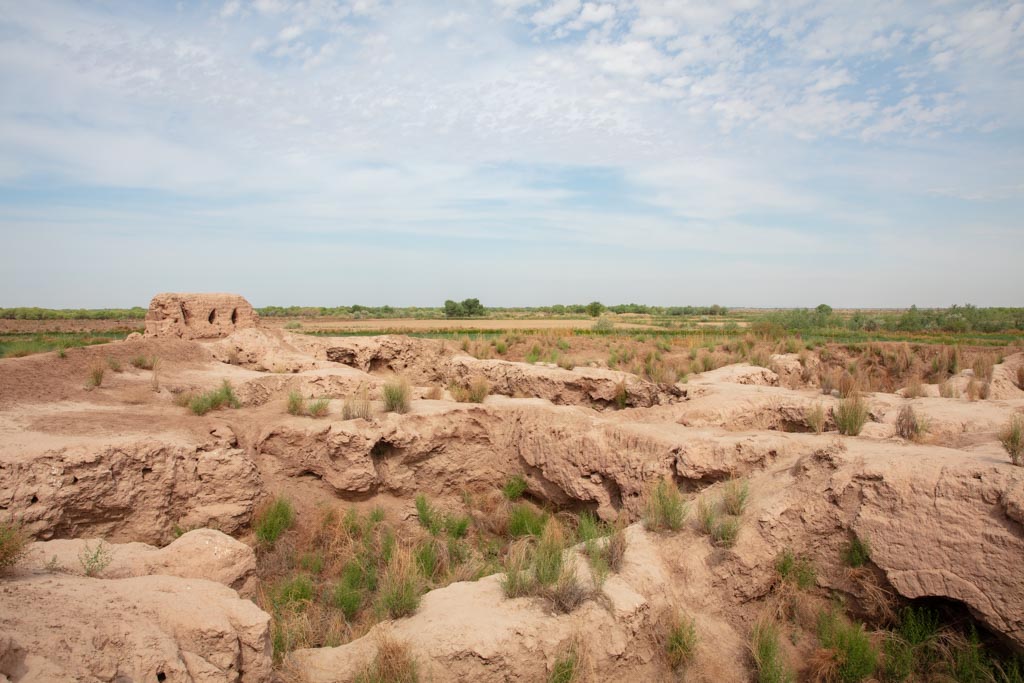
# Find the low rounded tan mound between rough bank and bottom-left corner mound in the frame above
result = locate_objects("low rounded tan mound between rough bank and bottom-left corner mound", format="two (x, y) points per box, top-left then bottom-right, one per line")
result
(26, 528), (256, 595)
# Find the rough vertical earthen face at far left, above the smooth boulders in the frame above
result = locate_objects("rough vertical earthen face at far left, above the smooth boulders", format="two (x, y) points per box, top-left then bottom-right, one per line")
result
(0, 440), (261, 543)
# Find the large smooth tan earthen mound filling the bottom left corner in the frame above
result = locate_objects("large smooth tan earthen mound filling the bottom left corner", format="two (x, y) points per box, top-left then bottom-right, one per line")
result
(0, 573), (271, 683)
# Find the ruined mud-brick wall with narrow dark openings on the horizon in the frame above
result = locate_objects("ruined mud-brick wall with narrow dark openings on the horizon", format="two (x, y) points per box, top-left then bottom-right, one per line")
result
(145, 293), (259, 339)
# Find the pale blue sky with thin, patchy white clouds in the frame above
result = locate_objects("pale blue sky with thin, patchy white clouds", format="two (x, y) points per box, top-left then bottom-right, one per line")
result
(0, 0), (1024, 307)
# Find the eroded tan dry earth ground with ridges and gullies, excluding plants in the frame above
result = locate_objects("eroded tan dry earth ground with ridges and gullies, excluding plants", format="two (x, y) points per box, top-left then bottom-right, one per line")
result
(0, 313), (1024, 682)
